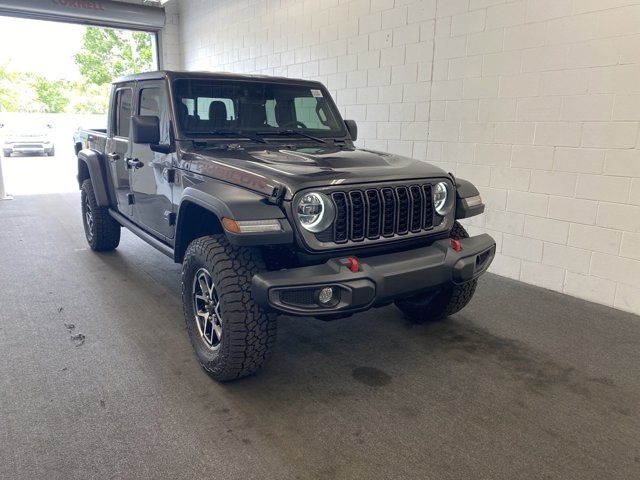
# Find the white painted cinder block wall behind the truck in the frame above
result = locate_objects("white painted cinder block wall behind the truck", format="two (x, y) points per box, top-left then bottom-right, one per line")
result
(178, 0), (640, 313)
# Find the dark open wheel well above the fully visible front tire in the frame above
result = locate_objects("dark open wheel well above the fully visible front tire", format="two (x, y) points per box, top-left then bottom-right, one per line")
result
(174, 202), (224, 263)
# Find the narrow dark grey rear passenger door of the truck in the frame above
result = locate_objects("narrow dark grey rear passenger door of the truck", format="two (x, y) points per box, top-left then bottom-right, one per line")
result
(105, 84), (134, 216)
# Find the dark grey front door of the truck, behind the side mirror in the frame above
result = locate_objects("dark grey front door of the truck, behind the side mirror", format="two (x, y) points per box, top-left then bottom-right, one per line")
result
(131, 82), (174, 239)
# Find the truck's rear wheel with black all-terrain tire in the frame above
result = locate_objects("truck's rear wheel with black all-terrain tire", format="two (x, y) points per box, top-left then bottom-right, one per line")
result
(80, 179), (121, 252)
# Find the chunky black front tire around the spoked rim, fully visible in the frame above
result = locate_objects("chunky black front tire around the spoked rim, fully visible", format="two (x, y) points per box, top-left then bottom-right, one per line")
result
(182, 235), (276, 382)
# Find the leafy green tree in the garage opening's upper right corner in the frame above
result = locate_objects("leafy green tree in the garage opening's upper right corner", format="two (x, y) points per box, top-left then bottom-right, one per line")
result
(75, 27), (153, 85)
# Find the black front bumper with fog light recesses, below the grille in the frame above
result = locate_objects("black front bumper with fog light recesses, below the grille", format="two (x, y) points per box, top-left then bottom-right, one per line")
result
(252, 234), (496, 316)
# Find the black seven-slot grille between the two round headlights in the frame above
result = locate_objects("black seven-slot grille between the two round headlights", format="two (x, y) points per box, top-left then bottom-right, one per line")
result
(317, 184), (434, 243)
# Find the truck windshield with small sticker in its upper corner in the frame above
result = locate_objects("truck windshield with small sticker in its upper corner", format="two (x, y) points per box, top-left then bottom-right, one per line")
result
(174, 79), (346, 139)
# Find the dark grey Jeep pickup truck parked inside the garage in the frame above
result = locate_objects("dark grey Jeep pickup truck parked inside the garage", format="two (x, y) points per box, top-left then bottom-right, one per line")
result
(76, 71), (496, 381)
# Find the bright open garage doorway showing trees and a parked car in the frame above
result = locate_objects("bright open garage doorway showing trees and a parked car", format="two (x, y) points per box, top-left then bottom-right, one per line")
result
(0, 13), (159, 196)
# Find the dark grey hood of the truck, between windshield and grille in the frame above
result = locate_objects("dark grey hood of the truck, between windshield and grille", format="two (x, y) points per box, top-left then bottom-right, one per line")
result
(183, 145), (449, 199)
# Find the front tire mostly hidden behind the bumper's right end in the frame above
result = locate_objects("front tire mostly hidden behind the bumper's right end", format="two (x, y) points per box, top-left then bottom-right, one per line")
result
(396, 222), (478, 323)
